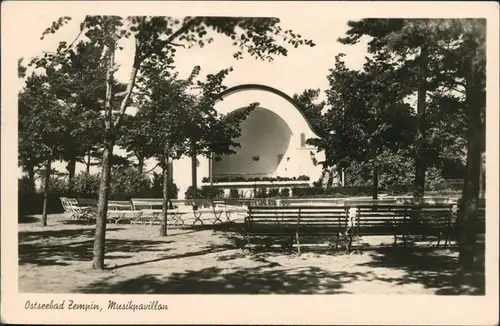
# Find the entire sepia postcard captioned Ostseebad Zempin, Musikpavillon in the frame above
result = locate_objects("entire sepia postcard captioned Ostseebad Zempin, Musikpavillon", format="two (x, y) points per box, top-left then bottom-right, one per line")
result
(2, 1), (499, 324)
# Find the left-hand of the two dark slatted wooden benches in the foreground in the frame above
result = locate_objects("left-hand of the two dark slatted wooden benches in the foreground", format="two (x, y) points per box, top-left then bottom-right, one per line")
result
(244, 206), (348, 254)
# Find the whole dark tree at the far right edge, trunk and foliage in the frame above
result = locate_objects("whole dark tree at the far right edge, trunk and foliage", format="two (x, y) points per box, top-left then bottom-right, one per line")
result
(450, 19), (486, 270)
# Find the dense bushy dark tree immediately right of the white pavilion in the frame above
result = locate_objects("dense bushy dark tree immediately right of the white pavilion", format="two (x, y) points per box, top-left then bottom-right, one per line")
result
(310, 53), (414, 198)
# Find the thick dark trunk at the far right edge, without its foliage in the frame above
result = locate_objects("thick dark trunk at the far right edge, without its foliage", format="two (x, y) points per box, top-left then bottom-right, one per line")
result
(457, 55), (484, 270)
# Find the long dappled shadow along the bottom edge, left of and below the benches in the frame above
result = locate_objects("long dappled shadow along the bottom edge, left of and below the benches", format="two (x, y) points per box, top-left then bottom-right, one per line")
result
(76, 265), (363, 294)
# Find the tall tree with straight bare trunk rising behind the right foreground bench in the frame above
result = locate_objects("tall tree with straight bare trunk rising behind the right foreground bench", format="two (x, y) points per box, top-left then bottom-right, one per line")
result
(339, 19), (456, 199)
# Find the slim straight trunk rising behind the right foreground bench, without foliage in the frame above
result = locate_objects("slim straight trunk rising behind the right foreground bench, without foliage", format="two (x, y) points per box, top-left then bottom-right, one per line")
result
(413, 45), (428, 201)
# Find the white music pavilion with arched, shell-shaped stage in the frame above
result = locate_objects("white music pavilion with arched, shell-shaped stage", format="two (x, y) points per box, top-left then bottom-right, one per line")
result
(171, 84), (338, 198)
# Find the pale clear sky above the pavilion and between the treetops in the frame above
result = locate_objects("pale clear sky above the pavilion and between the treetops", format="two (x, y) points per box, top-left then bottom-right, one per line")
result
(16, 13), (366, 100)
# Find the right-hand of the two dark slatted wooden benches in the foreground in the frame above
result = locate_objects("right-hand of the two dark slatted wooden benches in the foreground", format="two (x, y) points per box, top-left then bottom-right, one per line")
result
(349, 204), (453, 247)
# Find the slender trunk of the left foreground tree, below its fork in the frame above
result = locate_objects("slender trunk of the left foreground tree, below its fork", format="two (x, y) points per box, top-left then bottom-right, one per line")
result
(93, 139), (114, 270)
